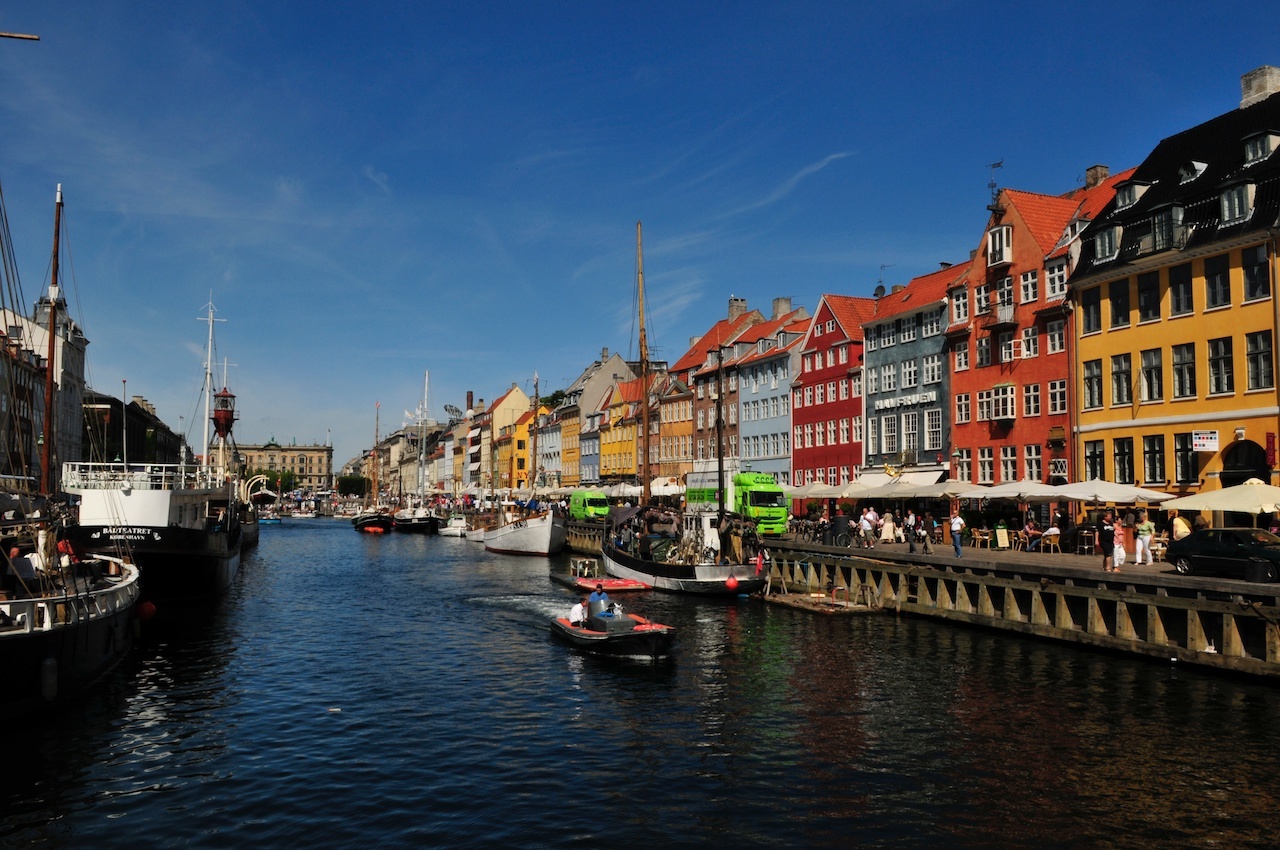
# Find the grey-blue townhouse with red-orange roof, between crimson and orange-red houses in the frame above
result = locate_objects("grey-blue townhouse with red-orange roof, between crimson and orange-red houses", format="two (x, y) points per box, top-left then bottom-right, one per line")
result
(860, 265), (968, 486)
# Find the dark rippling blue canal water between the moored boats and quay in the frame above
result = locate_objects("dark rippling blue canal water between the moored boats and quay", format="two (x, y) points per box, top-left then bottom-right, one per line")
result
(0, 518), (1280, 850)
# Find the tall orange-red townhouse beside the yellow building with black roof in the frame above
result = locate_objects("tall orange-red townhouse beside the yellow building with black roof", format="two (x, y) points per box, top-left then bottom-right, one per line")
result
(946, 165), (1130, 484)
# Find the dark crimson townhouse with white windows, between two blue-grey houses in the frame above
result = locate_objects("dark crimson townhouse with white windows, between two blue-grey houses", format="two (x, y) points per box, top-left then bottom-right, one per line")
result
(791, 294), (876, 486)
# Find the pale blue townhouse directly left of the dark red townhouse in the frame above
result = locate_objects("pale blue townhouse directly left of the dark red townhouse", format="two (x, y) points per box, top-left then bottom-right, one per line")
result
(726, 300), (809, 484)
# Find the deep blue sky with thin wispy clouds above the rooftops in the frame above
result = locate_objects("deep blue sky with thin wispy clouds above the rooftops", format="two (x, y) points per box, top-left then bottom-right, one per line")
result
(0, 0), (1280, 463)
